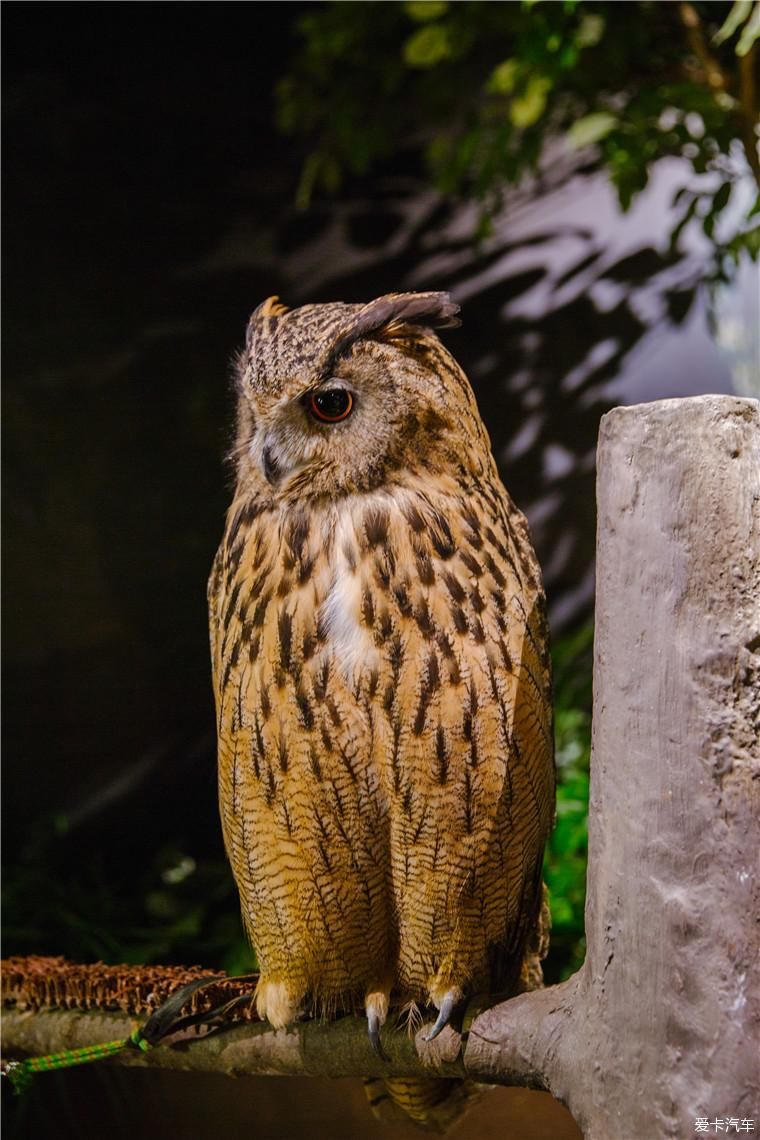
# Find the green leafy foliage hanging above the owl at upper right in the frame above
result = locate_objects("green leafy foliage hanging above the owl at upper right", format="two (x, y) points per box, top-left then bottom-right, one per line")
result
(278, 0), (760, 263)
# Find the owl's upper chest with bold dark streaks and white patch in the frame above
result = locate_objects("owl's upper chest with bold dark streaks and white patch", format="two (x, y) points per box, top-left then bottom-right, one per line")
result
(210, 474), (540, 724)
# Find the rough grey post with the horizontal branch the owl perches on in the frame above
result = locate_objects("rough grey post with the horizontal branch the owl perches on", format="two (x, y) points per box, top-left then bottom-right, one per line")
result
(2, 396), (760, 1140)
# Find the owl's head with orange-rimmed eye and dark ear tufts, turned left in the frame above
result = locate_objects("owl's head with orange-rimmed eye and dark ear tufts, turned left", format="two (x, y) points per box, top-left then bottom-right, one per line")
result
(235, 293), (488, 499)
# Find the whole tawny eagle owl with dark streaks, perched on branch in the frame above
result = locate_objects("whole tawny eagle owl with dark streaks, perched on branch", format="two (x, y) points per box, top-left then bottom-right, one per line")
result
(210, 293), (554, 1052)
